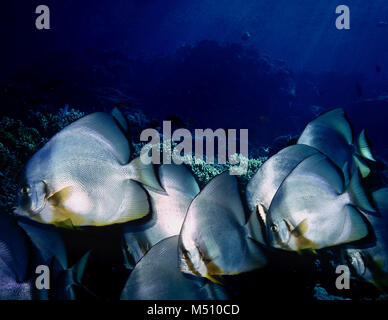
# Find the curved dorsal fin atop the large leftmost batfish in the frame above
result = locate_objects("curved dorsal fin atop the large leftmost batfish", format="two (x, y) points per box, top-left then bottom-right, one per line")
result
(64, 112), (130, 164)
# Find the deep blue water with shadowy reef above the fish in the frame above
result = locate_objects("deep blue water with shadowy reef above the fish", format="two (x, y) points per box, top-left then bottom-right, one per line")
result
(0, 0), (388, 154)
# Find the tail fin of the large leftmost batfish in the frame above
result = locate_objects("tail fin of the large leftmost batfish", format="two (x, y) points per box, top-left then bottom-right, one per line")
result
(125, 157), (164, 191)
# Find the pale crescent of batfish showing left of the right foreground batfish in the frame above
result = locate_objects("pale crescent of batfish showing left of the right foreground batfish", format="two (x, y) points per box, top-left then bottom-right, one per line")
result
(246, 144), (318, 211)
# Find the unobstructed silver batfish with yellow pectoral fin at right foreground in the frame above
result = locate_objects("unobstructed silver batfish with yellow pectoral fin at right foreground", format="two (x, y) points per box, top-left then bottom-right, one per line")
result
(266, 154), (373, 251)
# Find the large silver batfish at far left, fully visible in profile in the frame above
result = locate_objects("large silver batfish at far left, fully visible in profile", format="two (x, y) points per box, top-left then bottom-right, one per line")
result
(15, 112), (160, 226)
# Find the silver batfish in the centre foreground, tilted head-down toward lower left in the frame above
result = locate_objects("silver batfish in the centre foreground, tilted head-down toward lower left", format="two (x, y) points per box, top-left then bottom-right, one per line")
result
(179, 172), (267, 282)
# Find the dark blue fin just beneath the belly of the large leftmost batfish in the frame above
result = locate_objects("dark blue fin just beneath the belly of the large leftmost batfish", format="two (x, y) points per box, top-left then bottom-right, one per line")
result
(18, 220), (67, 269)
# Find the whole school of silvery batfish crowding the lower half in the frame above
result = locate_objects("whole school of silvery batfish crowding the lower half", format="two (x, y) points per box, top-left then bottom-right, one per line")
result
(0, 108), (388, 299)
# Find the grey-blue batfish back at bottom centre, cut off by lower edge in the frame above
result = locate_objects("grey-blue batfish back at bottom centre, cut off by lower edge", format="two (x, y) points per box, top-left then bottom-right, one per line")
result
(121, 236), (228, 300)
